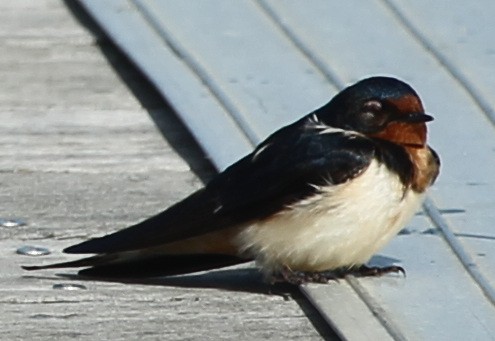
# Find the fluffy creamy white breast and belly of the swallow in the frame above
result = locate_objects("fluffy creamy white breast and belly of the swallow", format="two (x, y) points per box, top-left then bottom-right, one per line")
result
(236, 161), (423, 271)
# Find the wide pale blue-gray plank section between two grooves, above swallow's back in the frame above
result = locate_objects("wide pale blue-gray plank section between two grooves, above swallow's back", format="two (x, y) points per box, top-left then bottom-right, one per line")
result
(135, 0), (335, 144)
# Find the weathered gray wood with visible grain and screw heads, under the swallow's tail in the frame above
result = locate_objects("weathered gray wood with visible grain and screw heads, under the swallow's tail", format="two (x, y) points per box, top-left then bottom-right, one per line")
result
(0, 0), (334, 340)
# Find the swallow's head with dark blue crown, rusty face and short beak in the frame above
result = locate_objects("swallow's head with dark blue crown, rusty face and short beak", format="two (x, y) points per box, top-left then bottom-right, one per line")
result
(317, 77), (433, 147)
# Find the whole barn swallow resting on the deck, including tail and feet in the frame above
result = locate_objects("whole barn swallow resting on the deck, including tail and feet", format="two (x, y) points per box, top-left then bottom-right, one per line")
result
(24, 77), (440, 283)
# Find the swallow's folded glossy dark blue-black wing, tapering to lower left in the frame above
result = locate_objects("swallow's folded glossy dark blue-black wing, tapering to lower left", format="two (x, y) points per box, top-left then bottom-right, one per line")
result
(64, 120), (375, 253)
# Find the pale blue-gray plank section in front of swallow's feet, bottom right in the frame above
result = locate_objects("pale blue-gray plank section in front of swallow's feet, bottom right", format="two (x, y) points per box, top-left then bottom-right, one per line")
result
(358, 215), (495, 340)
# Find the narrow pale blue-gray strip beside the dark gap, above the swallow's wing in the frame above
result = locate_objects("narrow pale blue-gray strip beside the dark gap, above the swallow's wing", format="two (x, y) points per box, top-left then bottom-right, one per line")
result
(82, 0), (251, 166)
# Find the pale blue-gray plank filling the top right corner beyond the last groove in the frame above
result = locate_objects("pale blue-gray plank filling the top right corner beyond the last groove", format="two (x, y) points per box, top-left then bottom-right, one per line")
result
(384, 0), (495, 121)
